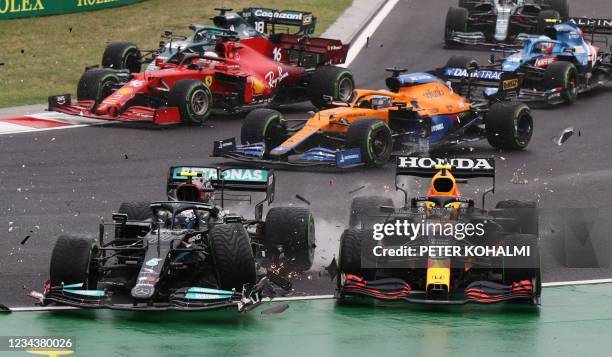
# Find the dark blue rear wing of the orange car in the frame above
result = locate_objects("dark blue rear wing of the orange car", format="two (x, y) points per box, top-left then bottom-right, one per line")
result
(436, 67), (523, 100)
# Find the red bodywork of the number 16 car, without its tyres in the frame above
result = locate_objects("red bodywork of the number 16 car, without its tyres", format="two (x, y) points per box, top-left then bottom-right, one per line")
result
(49, 34), (348, 125)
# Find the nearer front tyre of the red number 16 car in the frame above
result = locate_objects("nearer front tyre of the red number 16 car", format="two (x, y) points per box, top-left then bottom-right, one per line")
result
(168, 79), (213, 125)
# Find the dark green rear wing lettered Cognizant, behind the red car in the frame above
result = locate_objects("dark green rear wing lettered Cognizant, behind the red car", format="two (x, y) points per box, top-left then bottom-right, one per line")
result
(238, 7), (317, 35)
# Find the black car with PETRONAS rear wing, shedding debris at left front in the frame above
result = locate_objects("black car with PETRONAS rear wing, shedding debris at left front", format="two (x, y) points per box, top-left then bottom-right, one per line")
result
(31, 166), (315, 311)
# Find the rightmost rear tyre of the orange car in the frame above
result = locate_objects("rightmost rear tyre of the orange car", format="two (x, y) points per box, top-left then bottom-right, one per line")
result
(485, 102), (533, 150)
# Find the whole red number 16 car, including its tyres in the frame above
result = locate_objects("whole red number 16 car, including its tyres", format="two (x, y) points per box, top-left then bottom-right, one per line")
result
(49, 8), (354, 125)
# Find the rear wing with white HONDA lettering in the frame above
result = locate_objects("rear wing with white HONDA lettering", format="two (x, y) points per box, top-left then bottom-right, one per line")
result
(395, 156), (495, 208)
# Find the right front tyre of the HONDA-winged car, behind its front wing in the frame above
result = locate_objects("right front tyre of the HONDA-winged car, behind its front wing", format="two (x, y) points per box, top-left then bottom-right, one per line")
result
(503, 234), (542, 297)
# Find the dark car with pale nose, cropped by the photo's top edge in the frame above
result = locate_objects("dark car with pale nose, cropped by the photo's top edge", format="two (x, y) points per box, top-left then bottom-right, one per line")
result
(444, 0), (569, 46)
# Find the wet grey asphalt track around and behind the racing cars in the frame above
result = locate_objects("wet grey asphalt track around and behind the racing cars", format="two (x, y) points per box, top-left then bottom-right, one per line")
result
(0, 0), (612, 306)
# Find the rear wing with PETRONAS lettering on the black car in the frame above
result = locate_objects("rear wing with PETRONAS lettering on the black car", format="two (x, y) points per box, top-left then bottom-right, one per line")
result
(166, 166), (276, 219)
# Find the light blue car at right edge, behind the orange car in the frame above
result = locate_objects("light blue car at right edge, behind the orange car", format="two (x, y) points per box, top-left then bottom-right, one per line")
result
(446, 18), (612, 104)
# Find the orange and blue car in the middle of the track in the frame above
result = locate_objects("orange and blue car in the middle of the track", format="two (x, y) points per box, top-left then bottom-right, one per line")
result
(213, 68), (533, 167)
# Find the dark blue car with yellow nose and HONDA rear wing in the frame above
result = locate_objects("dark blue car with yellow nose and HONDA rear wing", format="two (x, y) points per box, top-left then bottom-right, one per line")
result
(337, 156), (541, 305)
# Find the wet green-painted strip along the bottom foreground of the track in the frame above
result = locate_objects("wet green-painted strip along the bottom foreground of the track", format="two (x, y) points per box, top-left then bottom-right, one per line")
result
(0, 284), (612, 357)
